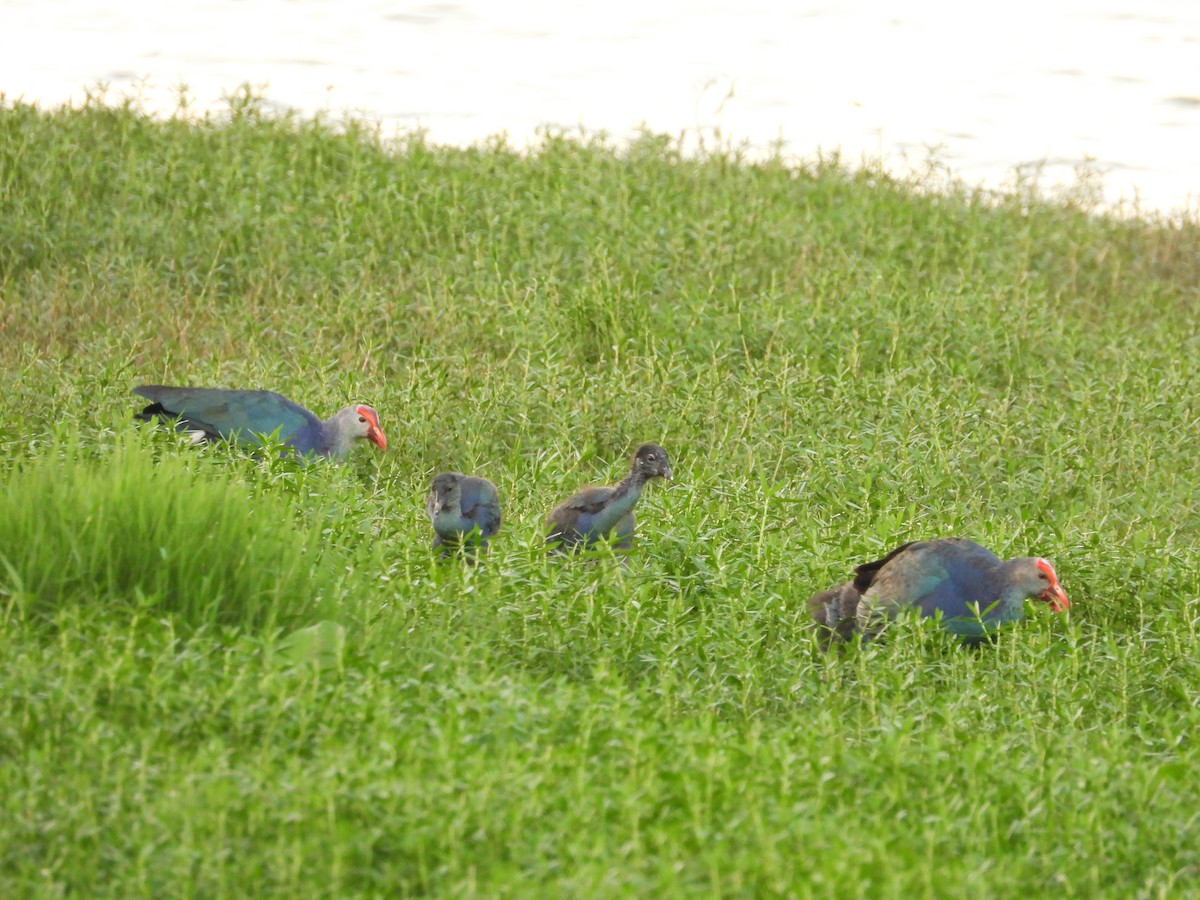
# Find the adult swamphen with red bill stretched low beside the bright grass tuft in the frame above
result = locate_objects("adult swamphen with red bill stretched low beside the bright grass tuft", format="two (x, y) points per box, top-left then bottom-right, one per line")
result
(133, 384), (388, 460)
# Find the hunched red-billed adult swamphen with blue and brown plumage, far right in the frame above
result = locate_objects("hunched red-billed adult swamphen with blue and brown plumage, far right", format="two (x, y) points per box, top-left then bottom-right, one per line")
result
(809, 538), (1070, 643)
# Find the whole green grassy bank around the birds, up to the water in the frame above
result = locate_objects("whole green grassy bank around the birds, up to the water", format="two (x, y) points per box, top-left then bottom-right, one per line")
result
(0, 96), (1200, 898)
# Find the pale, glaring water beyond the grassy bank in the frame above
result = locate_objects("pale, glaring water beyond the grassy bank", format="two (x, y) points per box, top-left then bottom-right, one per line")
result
(7, 0), (1200, 212)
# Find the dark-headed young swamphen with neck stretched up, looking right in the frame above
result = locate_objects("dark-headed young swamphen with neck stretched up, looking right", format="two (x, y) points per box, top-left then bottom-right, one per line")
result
(546, 444), (671, 550)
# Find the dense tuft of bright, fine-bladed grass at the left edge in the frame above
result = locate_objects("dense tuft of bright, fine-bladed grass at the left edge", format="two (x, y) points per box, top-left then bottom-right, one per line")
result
(0, 431), (350, 629)
